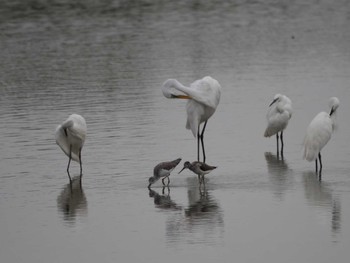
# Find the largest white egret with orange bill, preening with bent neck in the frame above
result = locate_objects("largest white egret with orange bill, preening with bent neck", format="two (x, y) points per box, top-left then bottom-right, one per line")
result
(162, 76), (221, 162)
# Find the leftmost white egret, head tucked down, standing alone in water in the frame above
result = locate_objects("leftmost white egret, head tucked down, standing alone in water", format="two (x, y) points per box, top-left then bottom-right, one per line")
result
(55, 114), (86, 182)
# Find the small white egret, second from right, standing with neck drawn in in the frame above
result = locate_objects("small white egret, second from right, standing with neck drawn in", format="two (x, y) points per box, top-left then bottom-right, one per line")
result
(264, 94), (293, 157)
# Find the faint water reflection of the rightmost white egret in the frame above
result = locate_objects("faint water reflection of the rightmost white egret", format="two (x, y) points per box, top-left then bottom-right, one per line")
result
(303, 171), (341, 237)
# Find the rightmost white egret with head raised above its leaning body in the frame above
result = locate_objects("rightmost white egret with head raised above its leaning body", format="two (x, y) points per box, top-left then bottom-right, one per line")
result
(303, 97), (339, 179)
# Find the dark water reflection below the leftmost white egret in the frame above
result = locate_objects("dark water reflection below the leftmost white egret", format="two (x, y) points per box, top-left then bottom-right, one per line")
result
(57, 177), (87, 224)
